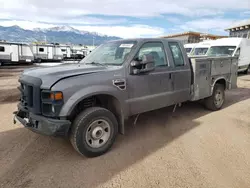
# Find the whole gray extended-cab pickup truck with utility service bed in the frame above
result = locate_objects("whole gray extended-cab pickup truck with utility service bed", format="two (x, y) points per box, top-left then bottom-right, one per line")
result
(14, 38), (238, 157)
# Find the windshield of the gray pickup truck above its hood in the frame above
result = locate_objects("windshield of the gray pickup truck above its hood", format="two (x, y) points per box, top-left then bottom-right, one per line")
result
(80, 41), (136, 66)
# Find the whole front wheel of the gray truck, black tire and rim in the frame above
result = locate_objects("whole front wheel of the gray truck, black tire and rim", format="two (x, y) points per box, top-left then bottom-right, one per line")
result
(70, 107), (118, 157)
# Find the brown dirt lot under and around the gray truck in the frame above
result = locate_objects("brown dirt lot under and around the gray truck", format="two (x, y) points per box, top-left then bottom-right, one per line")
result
(0, 65), (250, 188)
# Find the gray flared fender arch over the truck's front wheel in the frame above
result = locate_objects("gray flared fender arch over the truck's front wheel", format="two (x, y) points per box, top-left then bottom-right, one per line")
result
(59, 85), (128, 117)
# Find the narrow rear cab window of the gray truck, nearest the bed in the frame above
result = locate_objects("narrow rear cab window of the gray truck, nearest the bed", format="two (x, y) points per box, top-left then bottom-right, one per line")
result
(168, 42), (185, 67)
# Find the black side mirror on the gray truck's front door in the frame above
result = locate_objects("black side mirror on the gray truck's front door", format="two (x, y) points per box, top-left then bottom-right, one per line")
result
(130, 54), (155, 75)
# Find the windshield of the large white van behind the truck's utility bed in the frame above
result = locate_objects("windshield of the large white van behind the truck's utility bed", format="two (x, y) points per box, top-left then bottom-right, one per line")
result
(208, 46), (236, 56)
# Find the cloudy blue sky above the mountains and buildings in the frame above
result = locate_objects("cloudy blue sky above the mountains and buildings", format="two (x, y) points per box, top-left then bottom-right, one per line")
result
(0, 0), (250, 38)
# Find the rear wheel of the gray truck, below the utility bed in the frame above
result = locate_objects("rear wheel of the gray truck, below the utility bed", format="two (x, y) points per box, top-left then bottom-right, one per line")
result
(205, 84), (225, 111)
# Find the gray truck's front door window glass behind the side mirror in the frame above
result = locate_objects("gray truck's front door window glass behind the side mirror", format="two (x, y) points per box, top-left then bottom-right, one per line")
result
(136, 42), (167, 67)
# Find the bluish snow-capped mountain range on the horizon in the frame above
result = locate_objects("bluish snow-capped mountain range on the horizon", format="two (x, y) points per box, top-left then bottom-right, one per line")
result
(0, 26), (120, 45)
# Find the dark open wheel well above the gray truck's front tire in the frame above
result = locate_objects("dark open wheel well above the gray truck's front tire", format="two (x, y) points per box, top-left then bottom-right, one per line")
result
(68, 94), (124, 134)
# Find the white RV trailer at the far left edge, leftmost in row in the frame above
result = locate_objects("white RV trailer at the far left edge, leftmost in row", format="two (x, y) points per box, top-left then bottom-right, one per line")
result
(0, 42), (34, 66)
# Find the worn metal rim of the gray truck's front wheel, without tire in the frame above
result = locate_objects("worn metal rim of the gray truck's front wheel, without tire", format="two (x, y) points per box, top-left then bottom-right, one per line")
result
(85, 119), (111, 148)
